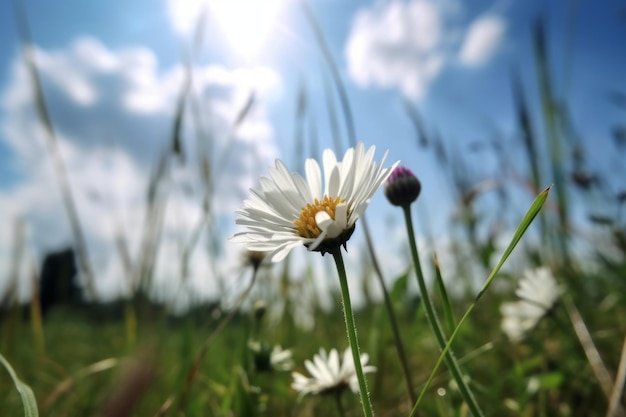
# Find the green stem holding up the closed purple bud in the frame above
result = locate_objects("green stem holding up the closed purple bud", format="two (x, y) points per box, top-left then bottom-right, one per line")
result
(402, 204), (483, 417)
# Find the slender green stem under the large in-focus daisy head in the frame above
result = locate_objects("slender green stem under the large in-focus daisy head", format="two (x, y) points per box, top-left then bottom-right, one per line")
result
(330, 246), (374, 417)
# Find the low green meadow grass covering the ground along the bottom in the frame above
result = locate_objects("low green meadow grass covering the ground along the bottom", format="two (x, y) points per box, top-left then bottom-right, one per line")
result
(0, 264), (626, 416)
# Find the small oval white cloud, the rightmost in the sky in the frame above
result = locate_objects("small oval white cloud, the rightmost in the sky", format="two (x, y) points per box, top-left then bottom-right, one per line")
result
(459, 15), (506, 67)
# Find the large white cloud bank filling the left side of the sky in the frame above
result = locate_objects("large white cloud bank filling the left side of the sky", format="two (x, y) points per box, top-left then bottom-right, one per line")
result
(0, 38), (280, 301)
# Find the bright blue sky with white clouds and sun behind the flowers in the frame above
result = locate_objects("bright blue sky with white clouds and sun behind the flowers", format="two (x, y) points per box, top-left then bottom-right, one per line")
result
(0, 0), (626, 308)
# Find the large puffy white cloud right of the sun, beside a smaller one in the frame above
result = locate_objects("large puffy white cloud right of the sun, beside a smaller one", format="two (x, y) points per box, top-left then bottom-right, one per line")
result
(346, 0), (456, 98)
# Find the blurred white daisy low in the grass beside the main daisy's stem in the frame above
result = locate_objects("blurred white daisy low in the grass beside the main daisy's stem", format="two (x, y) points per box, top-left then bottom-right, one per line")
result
(291, 348), (376, 395)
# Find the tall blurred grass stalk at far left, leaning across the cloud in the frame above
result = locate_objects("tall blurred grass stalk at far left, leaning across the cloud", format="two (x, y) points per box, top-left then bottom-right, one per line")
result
(13, 0), (98, 301)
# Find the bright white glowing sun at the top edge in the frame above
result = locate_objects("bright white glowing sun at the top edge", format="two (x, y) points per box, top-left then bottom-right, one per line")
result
(207, 0), (286, 58)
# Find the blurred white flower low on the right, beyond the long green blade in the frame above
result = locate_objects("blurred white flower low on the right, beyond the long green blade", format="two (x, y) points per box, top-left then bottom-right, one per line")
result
(500, 267), (561, 343)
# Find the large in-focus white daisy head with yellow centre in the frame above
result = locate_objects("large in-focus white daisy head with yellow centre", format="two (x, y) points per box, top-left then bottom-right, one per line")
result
(231, 143), (398, 262)
